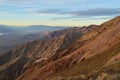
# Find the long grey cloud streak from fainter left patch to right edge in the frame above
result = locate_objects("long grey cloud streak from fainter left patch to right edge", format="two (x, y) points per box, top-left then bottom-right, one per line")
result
(37, 8), (120, 17)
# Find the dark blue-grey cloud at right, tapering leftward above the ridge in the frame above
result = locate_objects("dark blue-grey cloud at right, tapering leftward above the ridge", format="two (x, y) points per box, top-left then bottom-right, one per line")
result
(68, 8), (120, 16)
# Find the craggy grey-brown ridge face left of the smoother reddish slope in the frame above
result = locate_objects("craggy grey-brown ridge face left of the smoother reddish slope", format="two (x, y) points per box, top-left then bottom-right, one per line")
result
(0, 28), (94, 80)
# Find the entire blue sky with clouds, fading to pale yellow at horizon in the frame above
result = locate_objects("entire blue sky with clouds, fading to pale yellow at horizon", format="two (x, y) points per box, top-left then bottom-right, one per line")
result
(0, 0), (120, 26)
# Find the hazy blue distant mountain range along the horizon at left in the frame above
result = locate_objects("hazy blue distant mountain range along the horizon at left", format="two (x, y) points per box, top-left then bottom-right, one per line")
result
(0, 25), (69, 33)
